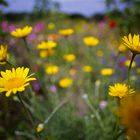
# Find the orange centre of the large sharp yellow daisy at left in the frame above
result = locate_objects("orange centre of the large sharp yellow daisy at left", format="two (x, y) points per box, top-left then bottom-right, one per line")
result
(5, 77), (24, 90)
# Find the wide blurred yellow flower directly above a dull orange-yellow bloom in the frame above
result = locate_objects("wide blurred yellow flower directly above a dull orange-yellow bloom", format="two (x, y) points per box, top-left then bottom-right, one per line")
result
(37, 41), (57, 49)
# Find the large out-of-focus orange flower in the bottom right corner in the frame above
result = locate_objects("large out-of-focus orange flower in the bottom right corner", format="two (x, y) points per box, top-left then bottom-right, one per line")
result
(119, 93), (140, 140)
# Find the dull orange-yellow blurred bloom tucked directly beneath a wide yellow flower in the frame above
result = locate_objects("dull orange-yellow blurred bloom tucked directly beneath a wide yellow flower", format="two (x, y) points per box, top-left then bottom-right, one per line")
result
(39, 49), (54, 58)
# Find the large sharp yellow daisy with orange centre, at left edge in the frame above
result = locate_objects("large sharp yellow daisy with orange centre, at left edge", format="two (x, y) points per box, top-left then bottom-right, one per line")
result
(0, 67), (36, 97)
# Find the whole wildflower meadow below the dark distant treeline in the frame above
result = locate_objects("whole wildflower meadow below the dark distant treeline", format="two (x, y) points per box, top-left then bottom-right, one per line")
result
(0, 0), (140, 140)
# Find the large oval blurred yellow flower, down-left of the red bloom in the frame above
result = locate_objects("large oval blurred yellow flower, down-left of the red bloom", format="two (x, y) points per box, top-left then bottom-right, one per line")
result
(83, 36), (99, 47)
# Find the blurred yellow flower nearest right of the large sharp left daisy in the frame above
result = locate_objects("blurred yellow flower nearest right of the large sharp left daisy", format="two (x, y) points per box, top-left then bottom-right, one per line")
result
(46, 64), (59, 75)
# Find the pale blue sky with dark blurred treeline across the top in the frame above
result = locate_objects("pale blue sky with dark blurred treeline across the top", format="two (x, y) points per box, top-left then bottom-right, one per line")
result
(0, 0), (140, 31)
